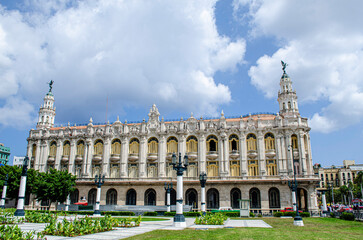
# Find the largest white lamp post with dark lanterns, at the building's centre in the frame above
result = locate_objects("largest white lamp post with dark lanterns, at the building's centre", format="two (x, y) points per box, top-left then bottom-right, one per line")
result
(172, 153), (188, 227)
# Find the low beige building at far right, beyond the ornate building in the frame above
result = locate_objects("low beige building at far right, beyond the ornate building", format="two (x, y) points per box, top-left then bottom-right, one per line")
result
(314, 160), (363, 190)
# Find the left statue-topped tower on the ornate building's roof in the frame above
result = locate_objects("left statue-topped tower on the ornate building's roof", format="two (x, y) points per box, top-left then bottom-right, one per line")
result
(37, 80), (55, 129)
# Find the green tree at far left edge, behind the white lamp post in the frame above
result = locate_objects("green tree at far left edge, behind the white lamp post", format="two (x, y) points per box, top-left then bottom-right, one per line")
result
(0, 165), (39, 199)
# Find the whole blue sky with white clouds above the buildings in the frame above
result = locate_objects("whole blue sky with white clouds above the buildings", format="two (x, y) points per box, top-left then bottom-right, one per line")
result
(0, 0), (363, 166)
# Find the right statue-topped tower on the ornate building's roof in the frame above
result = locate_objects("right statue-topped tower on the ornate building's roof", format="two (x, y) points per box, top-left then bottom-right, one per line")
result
(277, 61), (300, 117)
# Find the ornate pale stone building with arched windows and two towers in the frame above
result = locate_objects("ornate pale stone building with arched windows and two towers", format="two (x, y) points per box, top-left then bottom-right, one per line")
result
(27, 66), (319, 214)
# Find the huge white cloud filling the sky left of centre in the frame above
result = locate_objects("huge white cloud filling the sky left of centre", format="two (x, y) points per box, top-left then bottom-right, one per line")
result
(0, 0), (246, 125)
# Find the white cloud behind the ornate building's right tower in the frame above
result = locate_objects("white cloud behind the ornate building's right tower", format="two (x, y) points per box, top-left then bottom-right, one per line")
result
(234, 0), (363, 132)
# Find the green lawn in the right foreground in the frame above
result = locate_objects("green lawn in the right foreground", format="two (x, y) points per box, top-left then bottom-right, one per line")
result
(127, 218), (363, 240)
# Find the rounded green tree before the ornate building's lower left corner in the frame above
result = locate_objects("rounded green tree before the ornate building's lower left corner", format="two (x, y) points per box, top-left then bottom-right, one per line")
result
(33, 169), (76, 207)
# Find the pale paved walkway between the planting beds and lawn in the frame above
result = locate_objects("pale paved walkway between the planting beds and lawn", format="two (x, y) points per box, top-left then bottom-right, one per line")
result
(19, 218), (271, 240)
